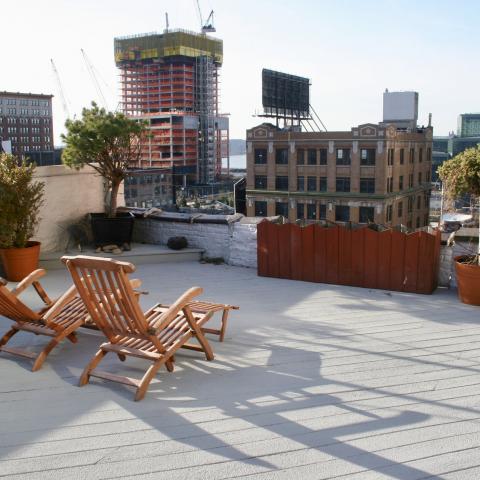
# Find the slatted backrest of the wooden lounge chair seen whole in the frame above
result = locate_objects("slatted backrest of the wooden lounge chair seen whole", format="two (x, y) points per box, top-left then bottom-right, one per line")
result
(62, 255), (148, 340)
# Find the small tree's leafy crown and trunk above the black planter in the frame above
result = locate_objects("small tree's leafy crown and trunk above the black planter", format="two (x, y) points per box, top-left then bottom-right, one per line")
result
(62, 102), (147, 217)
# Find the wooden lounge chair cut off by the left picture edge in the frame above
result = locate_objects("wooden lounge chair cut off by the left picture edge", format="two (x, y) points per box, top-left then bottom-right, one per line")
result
(0, 269), (88, 372)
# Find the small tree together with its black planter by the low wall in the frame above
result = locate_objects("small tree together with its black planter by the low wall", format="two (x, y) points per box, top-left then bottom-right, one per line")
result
(62, 102), (146, 247)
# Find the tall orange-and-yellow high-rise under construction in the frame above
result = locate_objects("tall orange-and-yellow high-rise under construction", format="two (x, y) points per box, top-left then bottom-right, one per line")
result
(115, 30), (228, 184)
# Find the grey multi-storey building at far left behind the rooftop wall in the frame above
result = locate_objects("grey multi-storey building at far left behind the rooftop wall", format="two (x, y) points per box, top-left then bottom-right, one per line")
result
(0, 92), (53, 156)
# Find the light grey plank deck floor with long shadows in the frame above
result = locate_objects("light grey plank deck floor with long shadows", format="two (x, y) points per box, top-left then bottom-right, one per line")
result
(0, 262), (480, 480)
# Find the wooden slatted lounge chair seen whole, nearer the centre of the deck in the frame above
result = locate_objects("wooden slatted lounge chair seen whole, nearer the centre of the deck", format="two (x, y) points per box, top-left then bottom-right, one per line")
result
(62, 256), (236, 400)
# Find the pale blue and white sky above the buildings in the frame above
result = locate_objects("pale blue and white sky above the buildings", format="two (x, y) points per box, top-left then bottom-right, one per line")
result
(0, 0), (480, 143)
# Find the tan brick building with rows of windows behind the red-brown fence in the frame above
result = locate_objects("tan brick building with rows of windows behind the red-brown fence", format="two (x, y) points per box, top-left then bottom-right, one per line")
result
(246, 122), (433, 229)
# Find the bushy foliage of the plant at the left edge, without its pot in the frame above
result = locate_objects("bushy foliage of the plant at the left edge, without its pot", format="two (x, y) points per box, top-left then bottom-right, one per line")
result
(0, 153), (45, 248)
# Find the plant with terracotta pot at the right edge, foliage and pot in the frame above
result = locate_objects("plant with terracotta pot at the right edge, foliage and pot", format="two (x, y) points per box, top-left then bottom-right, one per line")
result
(438, 145), (480, 305)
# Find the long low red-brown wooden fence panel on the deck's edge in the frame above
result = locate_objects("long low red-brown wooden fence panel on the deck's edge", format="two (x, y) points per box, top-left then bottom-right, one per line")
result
(257, 220), (441, 293)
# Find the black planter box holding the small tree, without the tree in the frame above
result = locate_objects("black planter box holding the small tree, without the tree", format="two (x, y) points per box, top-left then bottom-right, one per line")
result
(90, 212), (135, 247)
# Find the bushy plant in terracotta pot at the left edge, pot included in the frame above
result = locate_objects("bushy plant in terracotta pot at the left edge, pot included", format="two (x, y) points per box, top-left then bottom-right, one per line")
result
(0, 153), (45, 282)
